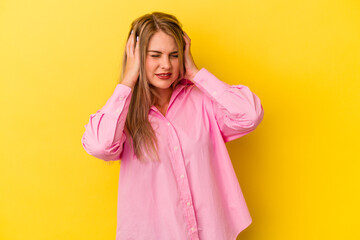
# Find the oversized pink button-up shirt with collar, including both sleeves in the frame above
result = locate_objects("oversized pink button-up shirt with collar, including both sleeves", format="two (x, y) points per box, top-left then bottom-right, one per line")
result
(81, 68), (264, 240)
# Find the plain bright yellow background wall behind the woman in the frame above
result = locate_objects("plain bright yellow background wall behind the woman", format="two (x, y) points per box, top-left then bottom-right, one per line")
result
(0, 0), (360, 240)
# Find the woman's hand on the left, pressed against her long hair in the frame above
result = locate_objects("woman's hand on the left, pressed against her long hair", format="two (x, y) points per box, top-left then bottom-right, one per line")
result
(121, 31), (140, 88)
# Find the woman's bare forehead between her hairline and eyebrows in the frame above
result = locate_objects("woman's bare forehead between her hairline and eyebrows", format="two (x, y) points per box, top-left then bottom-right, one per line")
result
(148, 31), (178, 52)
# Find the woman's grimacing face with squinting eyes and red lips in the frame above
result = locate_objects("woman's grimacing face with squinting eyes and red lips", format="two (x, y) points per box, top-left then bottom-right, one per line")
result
(145, 31), (180, 90)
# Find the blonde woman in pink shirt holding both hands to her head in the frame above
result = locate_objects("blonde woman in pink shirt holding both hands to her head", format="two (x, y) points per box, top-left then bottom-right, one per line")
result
(82, 12), (264, 240)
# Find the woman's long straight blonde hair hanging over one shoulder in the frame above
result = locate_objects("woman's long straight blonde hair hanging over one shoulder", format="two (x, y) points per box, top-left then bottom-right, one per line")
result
(120, 12), (185, 162)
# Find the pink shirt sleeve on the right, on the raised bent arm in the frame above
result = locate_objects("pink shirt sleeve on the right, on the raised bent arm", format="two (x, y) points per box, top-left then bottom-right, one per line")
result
(193, 68), (264, 142)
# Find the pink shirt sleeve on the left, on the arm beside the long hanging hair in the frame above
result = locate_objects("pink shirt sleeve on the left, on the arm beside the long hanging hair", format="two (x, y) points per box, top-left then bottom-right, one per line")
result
(81, 83), (131, 161)
